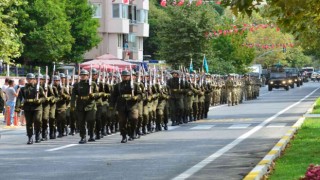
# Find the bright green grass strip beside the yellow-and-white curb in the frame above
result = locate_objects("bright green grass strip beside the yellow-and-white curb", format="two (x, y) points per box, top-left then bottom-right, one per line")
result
(268, 98), (320, 180)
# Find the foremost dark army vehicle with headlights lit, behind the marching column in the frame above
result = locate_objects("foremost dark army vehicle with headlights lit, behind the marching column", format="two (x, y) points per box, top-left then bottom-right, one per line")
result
(268, 72), (292, 91)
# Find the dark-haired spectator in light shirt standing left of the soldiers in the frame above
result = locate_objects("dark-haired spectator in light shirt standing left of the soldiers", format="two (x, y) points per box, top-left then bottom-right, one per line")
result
(6, 79), (20, 126)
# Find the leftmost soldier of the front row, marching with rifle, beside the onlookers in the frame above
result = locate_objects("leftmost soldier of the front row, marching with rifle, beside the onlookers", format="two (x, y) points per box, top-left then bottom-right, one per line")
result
(16, 73), (45, 144)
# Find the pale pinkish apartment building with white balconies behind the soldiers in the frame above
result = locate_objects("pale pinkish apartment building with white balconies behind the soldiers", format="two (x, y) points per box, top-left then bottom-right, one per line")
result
(85, 0), (149, 61)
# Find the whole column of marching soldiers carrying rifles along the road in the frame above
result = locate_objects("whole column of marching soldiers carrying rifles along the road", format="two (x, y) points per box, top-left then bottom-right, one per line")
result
(16, 67), (260, 144)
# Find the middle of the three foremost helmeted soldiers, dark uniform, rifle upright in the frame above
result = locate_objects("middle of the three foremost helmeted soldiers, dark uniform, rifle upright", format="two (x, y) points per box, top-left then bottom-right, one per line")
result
(70, 70), (97, 144)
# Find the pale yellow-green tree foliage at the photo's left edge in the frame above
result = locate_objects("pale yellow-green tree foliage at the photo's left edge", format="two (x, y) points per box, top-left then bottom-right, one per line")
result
(0, 0), (25, 62)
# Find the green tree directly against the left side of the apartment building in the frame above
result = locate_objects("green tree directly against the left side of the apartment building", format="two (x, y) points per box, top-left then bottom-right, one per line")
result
(63, 0), (101, 62)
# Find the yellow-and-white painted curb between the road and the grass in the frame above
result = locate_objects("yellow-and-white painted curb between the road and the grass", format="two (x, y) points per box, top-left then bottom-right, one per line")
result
(243, 103), (316, 180)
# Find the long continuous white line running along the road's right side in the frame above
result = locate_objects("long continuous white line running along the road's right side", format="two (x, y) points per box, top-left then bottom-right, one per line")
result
(173, 88), (320, 180)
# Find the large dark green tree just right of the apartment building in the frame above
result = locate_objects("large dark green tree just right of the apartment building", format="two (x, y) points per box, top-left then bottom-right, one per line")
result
(157, 3), (218, 68)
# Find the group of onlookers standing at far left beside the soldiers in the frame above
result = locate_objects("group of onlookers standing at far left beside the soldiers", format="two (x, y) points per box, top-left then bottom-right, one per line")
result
(0, 78), (25, 126)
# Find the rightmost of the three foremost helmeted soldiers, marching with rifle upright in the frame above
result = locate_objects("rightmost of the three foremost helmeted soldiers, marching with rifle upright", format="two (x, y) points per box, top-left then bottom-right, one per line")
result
(111, 71), (142, 143)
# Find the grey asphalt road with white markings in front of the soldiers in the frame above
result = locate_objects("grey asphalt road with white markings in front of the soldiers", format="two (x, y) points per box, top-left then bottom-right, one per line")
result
(0, 82), (320, 180)
